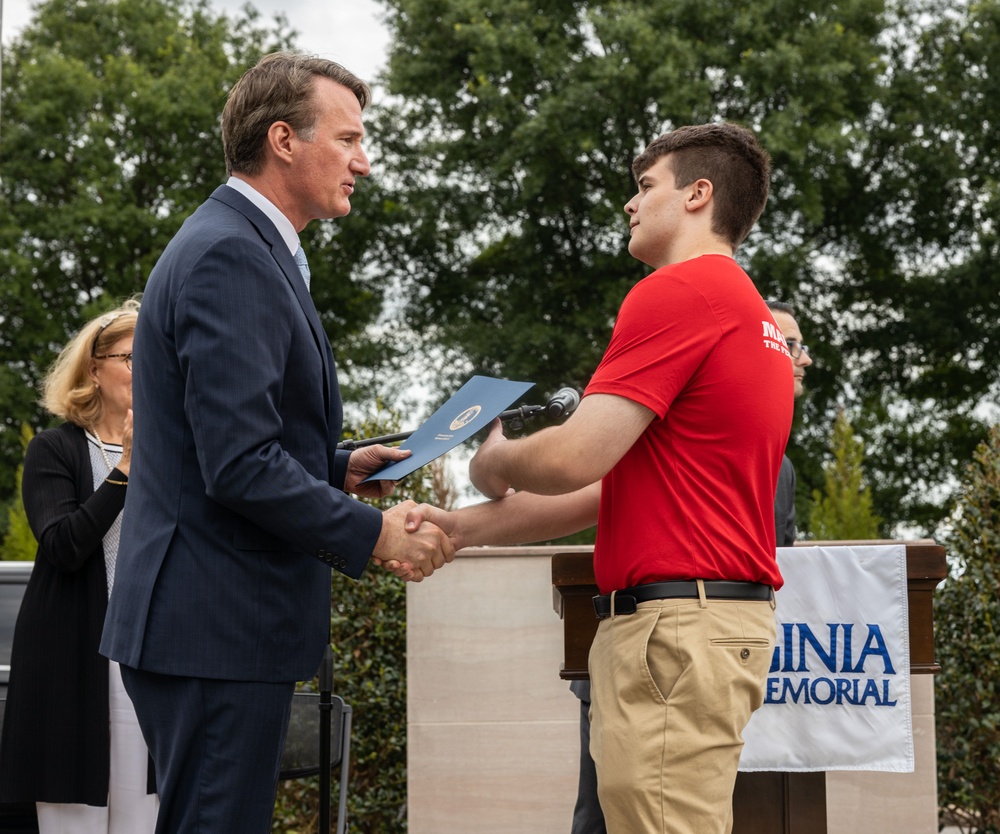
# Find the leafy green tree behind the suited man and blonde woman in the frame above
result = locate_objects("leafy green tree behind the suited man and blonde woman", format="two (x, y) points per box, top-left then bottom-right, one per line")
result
(0, 0), (406, 508)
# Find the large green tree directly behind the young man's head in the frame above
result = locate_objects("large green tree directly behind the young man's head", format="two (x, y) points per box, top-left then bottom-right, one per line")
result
(372, 0), (883, 404)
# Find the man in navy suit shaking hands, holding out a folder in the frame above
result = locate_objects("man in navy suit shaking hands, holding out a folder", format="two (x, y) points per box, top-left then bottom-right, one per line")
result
(101, 53), (454, 834)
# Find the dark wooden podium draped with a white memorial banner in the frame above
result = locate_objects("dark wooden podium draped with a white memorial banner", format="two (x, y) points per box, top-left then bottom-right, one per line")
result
(552, 541), (948, 834)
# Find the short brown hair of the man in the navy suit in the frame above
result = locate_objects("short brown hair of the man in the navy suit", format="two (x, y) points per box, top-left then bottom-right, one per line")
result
(222, 52), (371, 176)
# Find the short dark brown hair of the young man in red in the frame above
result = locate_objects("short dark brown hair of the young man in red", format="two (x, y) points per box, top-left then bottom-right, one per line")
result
(632, 122), (771, 249)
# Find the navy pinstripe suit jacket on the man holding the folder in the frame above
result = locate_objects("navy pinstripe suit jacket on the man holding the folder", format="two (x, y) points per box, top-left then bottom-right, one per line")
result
(101, 186), (382, 681)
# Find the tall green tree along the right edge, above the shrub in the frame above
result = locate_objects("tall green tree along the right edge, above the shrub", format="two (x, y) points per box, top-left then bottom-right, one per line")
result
(817, 0), (1000, 531)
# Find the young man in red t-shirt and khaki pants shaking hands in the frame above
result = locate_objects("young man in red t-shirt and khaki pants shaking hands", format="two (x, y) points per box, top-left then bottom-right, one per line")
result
(400, 124), (792, 834)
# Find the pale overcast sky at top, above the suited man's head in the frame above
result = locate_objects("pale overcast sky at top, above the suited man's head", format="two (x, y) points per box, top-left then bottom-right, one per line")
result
(0, 0), (388, 81)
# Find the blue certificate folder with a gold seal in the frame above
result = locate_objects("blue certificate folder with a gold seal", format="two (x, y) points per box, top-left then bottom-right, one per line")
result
(362, 376), (535, 483)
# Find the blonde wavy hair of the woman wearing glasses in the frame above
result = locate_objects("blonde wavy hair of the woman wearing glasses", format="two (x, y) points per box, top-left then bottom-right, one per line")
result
(42, 298), (139, 428)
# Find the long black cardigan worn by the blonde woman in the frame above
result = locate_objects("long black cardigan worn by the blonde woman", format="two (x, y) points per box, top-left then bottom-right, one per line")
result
(0, 423), (150, 806)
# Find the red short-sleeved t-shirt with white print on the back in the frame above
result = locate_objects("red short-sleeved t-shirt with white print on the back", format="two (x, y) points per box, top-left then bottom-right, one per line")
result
(585, 255), (793, 593)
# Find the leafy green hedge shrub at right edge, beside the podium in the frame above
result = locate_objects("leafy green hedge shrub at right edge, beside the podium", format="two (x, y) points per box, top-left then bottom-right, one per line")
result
(934, 427), (1000, 834)
